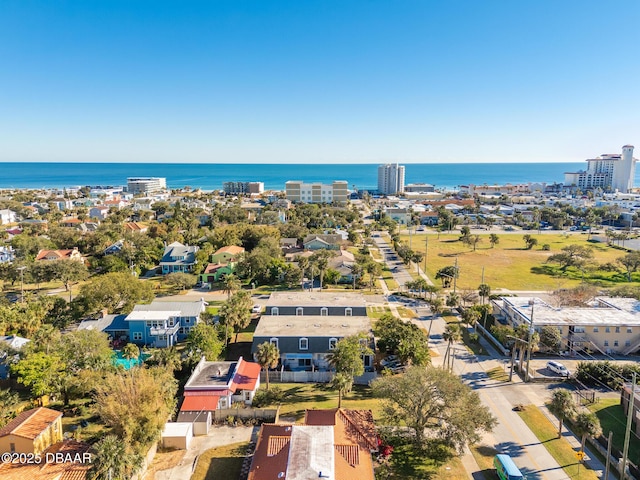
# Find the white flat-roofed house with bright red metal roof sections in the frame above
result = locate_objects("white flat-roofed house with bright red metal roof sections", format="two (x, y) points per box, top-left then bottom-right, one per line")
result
(178, 357), (260, 412)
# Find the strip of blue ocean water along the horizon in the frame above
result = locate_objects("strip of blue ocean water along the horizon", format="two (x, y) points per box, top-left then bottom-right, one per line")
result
(0, 162), (604, 190)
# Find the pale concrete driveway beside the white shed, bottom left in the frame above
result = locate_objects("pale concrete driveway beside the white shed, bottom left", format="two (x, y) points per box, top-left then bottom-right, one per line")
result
(154, 425), (260, 480)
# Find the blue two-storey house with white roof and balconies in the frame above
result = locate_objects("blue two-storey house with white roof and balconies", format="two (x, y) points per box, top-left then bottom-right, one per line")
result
(125, 299), (207, 347)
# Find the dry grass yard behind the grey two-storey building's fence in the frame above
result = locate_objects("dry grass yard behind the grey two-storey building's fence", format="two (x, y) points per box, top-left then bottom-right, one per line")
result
(260, 382), (382, 421)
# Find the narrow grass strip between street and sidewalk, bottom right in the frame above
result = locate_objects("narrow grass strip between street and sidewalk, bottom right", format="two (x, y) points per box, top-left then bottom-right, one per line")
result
(518, 405), (598, 480)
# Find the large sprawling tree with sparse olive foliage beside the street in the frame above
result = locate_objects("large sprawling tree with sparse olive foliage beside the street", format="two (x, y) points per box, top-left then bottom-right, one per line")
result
(372, 366), (496, 450)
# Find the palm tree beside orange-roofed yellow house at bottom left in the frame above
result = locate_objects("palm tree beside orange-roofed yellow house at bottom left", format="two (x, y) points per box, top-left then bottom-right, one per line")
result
(87, 435), (143, 480)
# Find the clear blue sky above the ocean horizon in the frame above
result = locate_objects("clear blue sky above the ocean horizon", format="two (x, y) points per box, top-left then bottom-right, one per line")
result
(0, 0), (640, 163)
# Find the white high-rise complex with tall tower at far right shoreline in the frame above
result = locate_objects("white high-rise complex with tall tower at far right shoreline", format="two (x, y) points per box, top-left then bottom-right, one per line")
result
(564, 145), (637, 193)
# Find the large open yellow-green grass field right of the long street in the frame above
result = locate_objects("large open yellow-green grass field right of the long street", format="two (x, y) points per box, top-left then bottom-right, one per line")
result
(402, 230), (625, 290)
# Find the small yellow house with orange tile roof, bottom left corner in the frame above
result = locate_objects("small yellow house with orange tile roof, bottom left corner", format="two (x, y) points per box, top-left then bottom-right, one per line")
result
(0, 407), (62, 455)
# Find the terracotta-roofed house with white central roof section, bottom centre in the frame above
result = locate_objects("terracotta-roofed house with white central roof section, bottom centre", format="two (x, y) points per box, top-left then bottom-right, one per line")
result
(248, 409), (378, 480)
